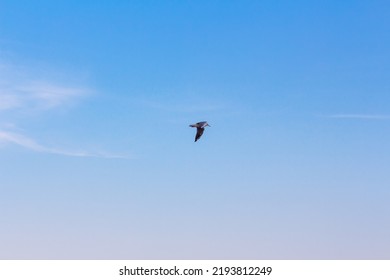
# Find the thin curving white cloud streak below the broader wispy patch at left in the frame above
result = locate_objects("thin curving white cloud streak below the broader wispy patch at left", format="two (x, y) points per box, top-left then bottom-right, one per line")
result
(0, 131), (130, 159)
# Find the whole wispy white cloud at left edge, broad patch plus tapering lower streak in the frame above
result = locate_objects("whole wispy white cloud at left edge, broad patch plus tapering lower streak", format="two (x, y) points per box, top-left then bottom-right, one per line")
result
(0, 61), (130, 158)
